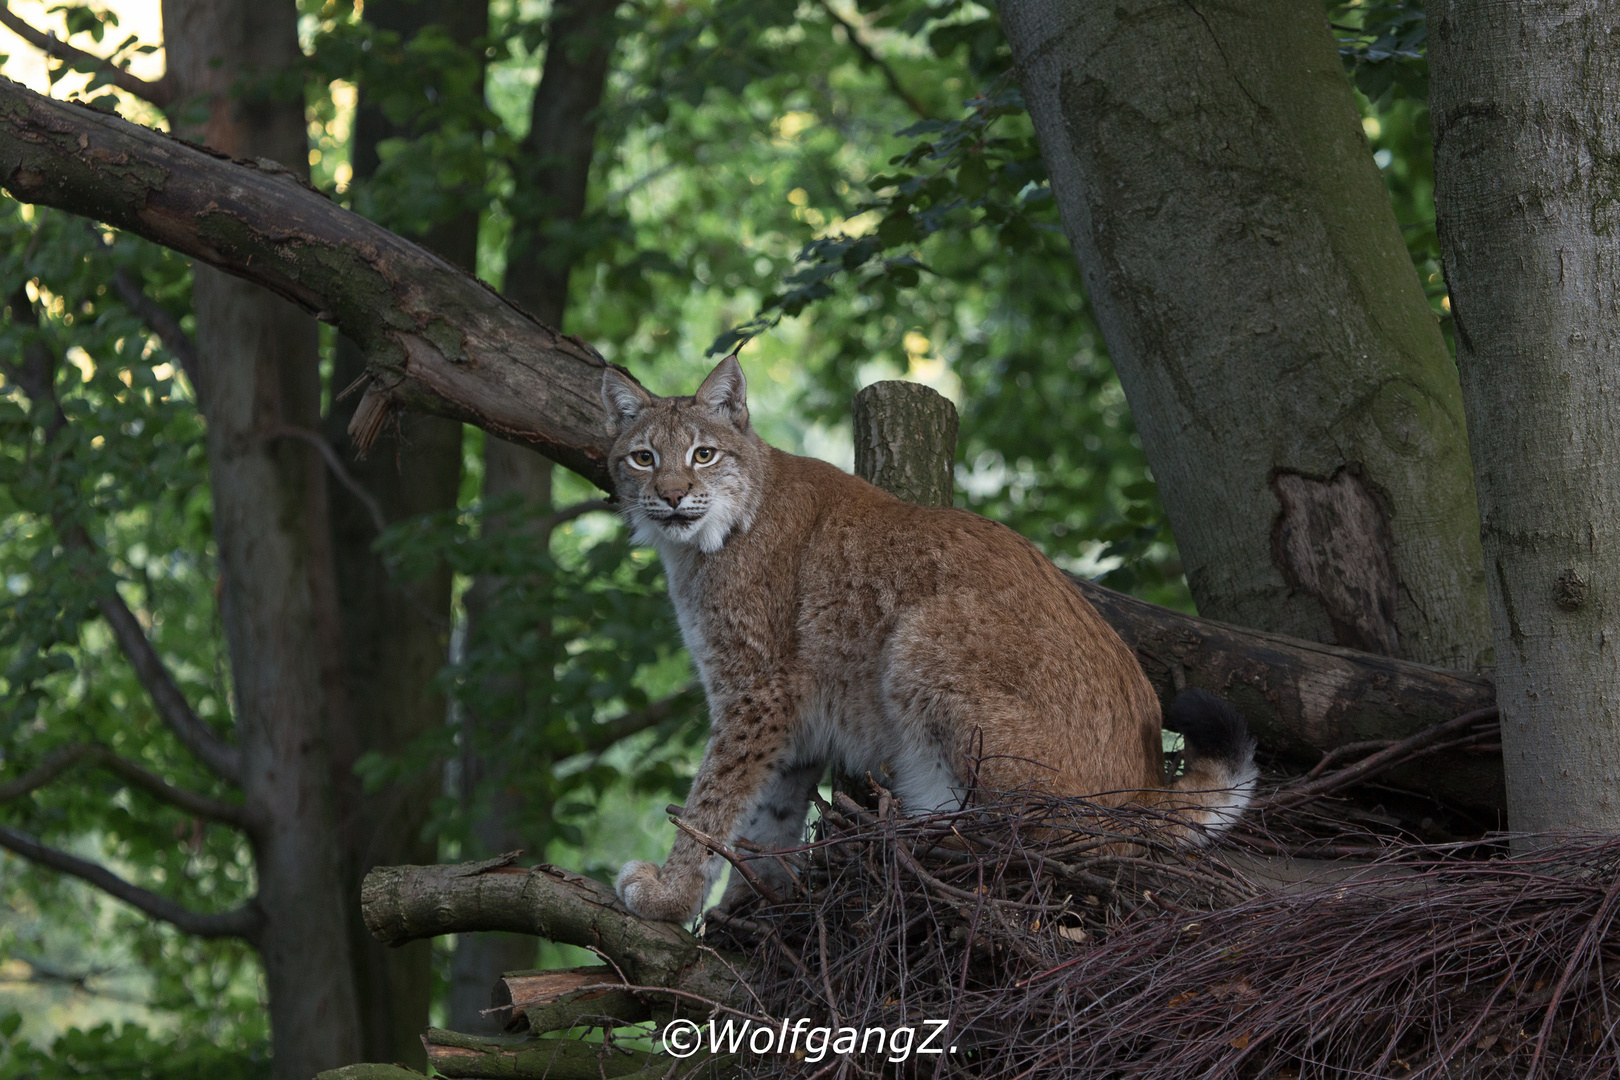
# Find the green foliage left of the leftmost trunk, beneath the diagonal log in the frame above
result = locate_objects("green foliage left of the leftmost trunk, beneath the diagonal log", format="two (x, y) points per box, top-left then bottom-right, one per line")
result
(0, 201), (258, 1023)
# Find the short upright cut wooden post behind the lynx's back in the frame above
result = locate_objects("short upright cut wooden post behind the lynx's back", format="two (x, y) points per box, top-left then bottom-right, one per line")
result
(851, 382), (959, 507)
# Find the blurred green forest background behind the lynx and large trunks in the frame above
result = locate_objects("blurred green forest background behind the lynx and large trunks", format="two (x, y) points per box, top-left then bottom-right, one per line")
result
(0, 0), (1448, 1077)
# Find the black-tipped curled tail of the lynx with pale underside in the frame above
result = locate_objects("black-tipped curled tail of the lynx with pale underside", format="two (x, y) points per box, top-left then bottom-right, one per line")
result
(1160, 690), (1260, 844)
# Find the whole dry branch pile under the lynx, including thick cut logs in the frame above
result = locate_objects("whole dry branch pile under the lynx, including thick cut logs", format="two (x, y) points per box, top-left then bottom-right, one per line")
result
(345, 711), (1620, 1080)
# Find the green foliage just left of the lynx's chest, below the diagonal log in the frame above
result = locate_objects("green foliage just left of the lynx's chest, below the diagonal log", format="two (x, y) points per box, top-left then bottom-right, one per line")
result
(370, 499), (705, 852)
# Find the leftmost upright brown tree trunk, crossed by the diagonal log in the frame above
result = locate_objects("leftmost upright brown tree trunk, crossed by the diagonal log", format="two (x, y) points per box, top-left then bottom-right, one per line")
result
(164, 0), (360, 1080)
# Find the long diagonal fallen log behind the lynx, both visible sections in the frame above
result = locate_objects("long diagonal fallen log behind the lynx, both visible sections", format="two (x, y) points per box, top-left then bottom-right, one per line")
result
(0, 79), (1503, 808)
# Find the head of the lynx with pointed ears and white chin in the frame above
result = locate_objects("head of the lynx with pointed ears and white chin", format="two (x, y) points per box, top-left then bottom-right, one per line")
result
(603, 356), (766, 552)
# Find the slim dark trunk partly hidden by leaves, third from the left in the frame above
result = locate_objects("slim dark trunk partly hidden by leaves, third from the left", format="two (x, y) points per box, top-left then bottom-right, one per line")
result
(450, 0), (617, 1031)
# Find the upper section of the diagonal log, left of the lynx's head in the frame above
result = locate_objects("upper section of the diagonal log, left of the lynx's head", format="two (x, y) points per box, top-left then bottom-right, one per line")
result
(0, 81), (622, 487)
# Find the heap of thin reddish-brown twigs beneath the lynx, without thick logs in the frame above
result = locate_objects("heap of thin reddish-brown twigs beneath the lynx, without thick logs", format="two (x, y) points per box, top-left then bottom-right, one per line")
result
(706, 709), (1620, 1080)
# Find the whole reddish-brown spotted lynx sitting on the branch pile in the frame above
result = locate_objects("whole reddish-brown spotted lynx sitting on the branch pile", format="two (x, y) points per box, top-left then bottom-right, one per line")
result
(603, 358), (1256, 921)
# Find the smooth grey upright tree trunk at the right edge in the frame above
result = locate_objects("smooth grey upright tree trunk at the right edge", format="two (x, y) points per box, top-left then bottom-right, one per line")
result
(1429, 2), (1620, 831)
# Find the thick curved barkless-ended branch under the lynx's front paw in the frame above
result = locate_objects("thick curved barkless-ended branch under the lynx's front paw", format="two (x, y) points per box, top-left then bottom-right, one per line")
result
(360, 857), (734, 999)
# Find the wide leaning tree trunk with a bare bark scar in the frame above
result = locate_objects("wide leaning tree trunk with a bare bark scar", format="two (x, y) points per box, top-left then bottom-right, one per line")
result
(1001, 0), (1490, 667)
